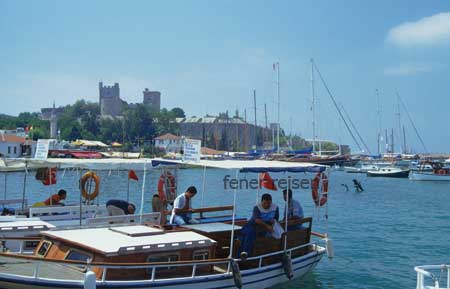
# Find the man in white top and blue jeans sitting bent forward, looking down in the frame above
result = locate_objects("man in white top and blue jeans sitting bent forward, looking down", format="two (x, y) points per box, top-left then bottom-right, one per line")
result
(170, 186), (199, 226)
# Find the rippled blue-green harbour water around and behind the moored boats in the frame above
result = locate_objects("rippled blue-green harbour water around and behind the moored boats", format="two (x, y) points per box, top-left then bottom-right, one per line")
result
(0, 169), (450, 289)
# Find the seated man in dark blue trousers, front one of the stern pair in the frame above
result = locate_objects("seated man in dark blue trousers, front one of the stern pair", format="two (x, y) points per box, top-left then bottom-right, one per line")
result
(238, 194), (280, 255)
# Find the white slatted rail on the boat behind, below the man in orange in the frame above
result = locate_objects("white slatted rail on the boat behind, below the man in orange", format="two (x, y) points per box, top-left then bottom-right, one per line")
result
(30, 205), (108, 221)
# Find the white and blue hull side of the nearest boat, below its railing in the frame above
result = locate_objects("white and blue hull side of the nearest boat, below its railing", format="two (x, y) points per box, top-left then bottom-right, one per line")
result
(0, 246), (325, 289)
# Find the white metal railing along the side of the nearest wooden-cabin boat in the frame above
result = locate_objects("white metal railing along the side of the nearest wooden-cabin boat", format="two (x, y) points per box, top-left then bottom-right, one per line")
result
(0, 238), (317, 283)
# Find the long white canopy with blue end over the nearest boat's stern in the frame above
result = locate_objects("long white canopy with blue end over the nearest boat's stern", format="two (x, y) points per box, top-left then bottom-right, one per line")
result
(152, 159), (327, 173)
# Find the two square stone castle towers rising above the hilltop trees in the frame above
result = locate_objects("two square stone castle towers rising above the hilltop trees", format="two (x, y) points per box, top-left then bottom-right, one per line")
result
(98, 82), (161, 117)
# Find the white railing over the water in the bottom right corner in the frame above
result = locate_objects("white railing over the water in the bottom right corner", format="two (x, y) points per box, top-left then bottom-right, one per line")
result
(414, 264), (450, 289)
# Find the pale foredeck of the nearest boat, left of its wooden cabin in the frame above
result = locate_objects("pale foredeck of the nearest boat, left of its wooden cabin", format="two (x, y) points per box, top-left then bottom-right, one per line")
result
(0, 256), (84, 280)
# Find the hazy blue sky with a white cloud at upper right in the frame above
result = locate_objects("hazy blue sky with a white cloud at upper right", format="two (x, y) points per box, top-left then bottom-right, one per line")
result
(0, 0), (450, 153)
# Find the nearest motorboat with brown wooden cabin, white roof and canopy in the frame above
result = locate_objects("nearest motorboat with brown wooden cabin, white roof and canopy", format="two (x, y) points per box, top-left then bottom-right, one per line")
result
(0, 160), (333, 289)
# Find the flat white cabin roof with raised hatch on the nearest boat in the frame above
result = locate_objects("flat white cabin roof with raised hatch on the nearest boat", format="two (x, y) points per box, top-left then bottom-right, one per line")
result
(42, 225), (216, 256)
